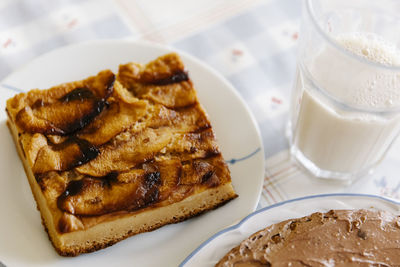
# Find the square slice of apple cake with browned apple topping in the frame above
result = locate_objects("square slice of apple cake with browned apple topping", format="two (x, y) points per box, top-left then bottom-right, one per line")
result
(6, 54), (237, 256)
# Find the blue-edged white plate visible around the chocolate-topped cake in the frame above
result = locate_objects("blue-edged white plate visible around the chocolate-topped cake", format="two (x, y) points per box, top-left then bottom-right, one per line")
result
(180, 194), (400, 267)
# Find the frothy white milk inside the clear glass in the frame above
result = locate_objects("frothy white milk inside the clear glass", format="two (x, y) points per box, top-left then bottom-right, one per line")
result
(292, 34), (400, 173)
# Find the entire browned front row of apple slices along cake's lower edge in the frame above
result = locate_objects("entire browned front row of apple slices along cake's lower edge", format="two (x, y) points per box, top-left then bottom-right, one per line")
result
(57, 157), (228, 219)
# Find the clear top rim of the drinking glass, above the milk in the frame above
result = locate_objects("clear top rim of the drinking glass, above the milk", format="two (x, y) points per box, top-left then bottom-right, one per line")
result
(306, 0), (400, 72)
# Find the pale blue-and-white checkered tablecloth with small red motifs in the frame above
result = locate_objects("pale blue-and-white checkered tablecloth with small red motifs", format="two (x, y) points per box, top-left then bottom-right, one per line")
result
(0, 0), (400, 216)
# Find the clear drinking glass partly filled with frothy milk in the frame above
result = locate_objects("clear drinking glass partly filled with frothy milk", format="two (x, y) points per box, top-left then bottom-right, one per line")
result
(288, 0), (400, 182)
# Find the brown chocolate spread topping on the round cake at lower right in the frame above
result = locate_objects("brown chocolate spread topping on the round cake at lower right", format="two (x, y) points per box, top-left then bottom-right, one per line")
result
(216, 210), (400, 267)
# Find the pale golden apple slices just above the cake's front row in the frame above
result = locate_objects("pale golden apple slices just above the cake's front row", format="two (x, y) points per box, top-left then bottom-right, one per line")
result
(77, 127), (219, 177)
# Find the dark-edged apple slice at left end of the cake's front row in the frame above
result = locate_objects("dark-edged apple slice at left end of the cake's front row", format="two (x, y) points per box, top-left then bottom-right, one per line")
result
(57, 171), (161, 216)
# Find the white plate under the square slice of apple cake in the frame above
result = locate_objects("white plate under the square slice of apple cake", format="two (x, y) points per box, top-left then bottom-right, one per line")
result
(0, 41), (264, 266)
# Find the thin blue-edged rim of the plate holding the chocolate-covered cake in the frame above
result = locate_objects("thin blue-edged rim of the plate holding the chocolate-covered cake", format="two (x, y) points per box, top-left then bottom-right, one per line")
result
(179, 193), (400, 267)
